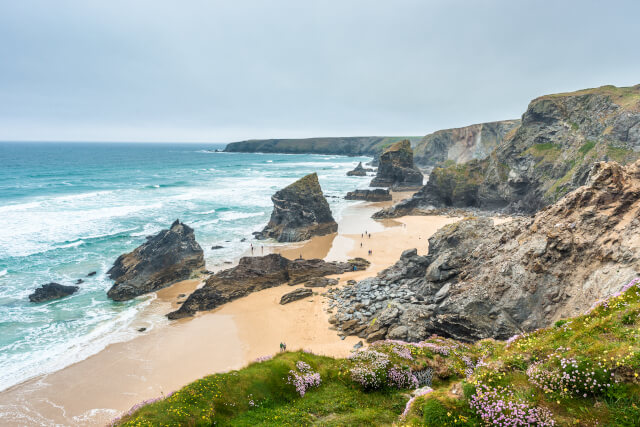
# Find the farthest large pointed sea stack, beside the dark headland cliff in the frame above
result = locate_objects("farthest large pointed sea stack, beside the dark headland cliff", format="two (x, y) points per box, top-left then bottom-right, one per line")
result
(370, 139), (423, 191)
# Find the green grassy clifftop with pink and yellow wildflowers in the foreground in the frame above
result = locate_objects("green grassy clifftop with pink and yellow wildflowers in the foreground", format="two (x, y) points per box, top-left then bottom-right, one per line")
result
(116, 284), (640, 426)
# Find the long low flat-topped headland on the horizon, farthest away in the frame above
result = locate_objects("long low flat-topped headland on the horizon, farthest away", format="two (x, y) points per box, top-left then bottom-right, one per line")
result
(224, 136), (421, 158)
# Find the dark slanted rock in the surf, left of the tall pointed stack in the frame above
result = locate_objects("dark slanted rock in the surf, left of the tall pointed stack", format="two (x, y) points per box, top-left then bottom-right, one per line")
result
(107, 220), (204, 301)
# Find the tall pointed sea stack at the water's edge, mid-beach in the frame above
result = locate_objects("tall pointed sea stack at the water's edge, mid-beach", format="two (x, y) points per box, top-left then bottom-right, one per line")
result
(254, 173), (338, 242)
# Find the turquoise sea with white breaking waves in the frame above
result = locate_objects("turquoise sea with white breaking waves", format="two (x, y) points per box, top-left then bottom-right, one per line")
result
(0, 142), (371, 391)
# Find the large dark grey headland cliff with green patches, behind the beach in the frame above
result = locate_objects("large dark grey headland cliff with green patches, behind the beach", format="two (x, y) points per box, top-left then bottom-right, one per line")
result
(378, 85), (640, 217)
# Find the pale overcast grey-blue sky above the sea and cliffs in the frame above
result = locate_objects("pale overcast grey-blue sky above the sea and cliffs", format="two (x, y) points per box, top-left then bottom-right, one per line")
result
(0, 0), (640, 142)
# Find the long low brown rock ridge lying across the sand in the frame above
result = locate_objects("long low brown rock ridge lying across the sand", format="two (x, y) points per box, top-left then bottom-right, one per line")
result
(169, 254), (368, 319)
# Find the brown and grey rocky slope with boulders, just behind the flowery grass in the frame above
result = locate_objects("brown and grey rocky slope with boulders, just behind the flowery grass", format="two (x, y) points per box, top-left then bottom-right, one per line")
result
(330, 161), (640, 341)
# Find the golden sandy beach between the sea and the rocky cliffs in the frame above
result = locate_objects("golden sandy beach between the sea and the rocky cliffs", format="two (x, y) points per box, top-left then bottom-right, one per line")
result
(0, 194), (457, 425)
